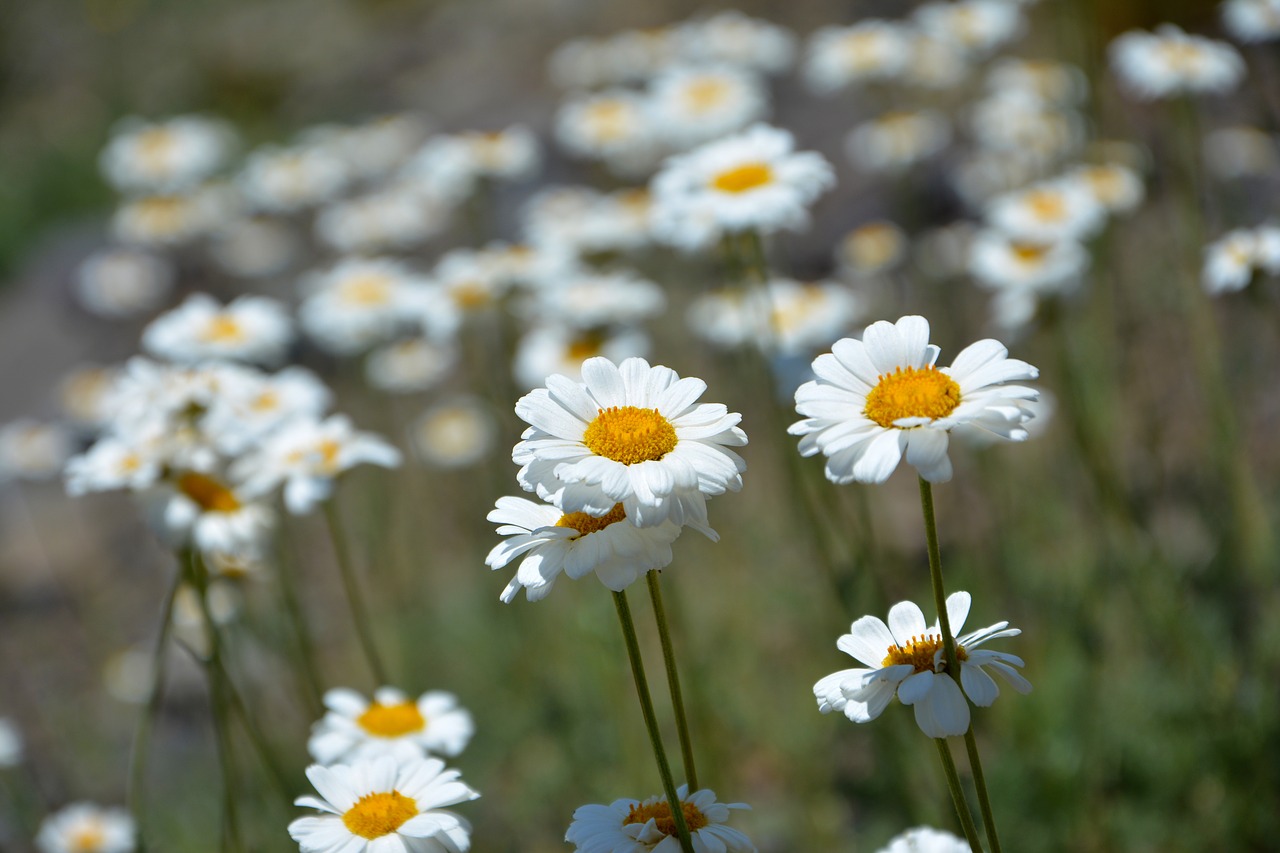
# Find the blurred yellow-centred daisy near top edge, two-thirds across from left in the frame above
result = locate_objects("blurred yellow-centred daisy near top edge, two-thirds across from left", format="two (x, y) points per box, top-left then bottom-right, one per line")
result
(804, 19), (911, 92)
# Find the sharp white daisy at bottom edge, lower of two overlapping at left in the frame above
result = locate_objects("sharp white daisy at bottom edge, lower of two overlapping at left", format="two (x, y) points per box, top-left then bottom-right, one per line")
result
(289, 757), (480, 853)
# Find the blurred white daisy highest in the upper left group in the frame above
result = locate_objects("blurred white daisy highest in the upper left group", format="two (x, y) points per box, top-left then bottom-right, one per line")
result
(99, 115), (234, 192)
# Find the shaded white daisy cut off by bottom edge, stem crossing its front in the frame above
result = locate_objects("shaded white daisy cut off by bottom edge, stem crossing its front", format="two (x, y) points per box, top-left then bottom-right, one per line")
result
(564, 785), (755, 853)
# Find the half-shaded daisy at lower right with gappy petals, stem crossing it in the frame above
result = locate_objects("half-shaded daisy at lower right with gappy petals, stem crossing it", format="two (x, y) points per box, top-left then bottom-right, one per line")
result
(813, 592), (1032, 738)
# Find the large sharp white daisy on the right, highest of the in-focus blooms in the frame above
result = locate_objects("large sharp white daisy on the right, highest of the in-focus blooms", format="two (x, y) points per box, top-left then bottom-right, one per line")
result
(788, 316), (1039, 483)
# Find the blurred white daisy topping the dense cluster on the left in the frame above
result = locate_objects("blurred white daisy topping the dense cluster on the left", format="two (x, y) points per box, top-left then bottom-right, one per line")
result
(142, 293), (293, 364)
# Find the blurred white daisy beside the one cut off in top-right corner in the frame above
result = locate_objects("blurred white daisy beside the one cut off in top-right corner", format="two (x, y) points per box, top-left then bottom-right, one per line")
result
(1107, 24), (1244, 100)
